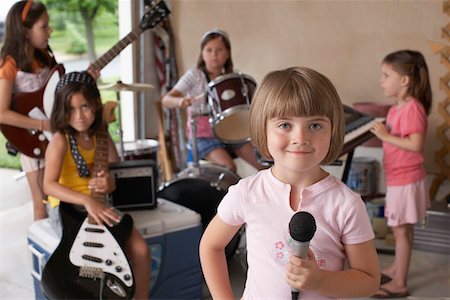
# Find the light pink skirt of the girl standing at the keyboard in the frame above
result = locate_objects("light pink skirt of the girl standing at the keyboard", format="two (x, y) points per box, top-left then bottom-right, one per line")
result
(384, 178), (430, 227)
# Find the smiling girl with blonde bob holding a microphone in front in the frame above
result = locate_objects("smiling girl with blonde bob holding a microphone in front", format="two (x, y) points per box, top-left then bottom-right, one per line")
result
(200, 67), (380, 300)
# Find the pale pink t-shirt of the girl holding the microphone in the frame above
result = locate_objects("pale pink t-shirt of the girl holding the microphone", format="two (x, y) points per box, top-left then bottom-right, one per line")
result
(218, 169), (374, 299)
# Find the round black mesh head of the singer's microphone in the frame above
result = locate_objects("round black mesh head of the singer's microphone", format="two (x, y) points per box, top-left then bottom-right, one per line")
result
(289, 211), (316, 242)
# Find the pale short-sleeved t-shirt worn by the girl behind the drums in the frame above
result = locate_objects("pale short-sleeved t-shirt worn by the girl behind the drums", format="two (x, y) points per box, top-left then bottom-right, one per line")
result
(173, 69), (214, 138)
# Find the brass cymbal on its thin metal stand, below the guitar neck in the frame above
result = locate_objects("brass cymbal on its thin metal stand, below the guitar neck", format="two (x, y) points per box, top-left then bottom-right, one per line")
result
(99, 80), (154, 161)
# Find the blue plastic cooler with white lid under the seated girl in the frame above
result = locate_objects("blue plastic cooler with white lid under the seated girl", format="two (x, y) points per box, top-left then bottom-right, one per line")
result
(28, 199), (203, 299)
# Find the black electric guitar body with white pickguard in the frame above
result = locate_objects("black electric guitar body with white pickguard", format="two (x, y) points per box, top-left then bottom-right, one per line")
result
(41, 202), (134, 299)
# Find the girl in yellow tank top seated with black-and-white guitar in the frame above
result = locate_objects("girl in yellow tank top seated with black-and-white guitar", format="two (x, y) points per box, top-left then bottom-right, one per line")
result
(44, 72), (150, 299)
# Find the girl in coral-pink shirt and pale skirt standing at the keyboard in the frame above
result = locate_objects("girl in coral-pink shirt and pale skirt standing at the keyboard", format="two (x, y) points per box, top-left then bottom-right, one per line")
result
(371, 50), (432, 298)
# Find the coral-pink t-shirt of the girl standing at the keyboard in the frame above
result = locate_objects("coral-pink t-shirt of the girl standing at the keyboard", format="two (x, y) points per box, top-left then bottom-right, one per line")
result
(383, 99), (428, 186)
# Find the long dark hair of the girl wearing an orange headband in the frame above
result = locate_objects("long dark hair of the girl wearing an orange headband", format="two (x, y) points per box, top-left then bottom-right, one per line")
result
(0, 1), (56, 72)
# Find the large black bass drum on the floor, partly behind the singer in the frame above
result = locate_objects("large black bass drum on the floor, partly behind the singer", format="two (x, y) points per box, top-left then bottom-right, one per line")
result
(158, 164), (241, 259)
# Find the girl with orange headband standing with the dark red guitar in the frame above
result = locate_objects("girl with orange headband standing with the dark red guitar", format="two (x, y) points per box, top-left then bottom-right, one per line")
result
(0, 0), (100, 220)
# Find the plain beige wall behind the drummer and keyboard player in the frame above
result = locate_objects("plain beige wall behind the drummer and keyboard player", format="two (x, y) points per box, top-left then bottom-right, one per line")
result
(169, 0), (449, 172)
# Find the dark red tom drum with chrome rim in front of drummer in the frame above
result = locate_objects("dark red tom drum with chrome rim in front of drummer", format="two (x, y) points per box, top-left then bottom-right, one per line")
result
(207, 73), (256, 144)
